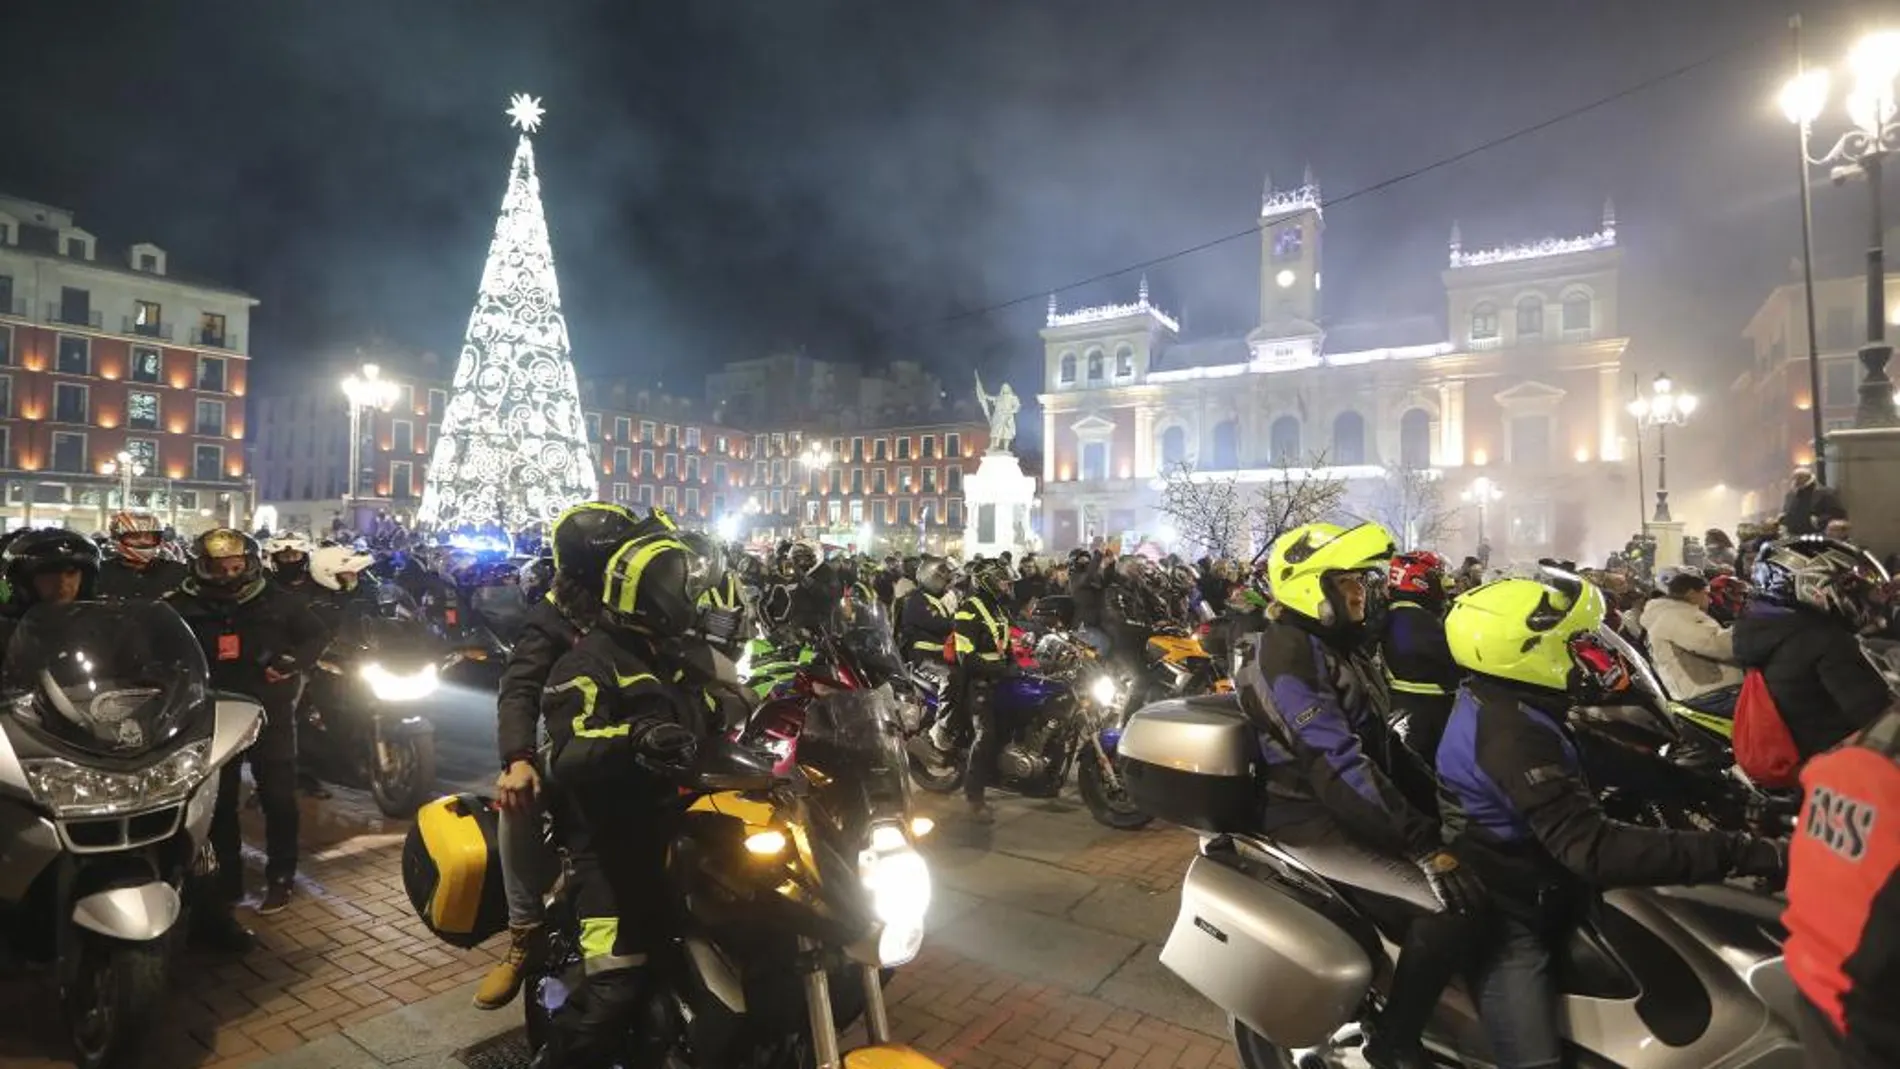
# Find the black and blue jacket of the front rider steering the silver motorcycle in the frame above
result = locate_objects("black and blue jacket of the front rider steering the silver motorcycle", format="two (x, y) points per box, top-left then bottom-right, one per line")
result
(1438, 678), (1739, 921)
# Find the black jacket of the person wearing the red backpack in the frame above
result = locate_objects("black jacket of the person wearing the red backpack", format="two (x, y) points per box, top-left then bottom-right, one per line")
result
(1731, 604), (1892, 760)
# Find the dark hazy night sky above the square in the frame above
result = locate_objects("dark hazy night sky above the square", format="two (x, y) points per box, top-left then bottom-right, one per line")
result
(0, 0), (1896, 476)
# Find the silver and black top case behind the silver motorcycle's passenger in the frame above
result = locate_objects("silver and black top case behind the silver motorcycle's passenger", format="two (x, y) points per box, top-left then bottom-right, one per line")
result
(1117, 695), (1260, 835)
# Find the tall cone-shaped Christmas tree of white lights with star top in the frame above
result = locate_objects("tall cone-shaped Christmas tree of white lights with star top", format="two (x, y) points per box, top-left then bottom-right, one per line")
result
(416, 93), (600, 532)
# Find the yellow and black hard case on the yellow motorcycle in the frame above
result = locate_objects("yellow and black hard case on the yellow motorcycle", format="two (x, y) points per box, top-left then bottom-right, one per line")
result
(403, 794), (507, 949)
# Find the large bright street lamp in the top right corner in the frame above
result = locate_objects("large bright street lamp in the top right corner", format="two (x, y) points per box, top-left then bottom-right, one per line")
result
(1780, 19), (1900, 429)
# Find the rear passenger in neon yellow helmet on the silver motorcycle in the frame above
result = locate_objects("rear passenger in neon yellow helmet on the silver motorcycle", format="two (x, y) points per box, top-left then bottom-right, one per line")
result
(1235, 524), (1484, 1067)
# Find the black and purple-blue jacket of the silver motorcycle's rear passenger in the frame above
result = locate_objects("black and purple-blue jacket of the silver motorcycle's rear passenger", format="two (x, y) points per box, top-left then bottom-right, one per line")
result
(1237, 621), (1440, 858)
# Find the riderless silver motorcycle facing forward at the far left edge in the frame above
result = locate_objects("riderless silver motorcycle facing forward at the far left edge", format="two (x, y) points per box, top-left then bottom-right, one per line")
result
(0, 602), (264, 1069)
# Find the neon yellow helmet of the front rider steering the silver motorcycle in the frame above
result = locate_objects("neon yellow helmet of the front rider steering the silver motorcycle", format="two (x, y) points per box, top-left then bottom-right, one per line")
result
(1444, 575), (1628, 691)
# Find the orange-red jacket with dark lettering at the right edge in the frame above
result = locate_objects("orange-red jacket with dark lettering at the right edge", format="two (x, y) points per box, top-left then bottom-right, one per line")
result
(1782, 714), (1900, 1065)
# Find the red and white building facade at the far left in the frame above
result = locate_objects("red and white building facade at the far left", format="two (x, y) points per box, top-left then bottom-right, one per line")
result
(0, 196), (258, 532)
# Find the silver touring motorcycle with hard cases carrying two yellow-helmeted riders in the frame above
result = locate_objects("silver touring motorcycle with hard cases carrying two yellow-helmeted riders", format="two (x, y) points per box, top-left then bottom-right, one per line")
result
(1121, 695), (1803, 1069)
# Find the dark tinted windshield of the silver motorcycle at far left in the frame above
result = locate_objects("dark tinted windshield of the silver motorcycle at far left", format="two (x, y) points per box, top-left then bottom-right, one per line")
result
(0, 602), (211, 758)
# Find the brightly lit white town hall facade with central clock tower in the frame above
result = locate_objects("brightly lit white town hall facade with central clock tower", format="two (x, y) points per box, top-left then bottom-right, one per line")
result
(1039, 182), (1636, 560)
